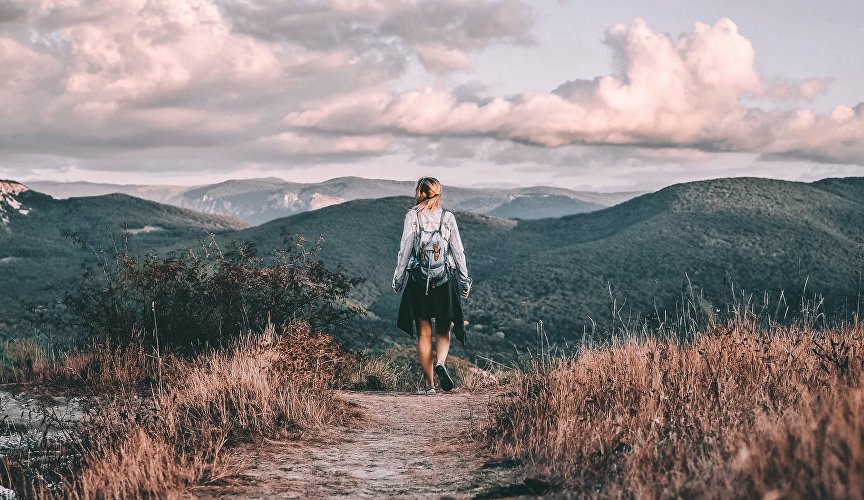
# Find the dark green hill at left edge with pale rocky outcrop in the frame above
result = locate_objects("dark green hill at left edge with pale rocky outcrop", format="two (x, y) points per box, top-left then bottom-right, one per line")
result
(0, 181), (248, 330)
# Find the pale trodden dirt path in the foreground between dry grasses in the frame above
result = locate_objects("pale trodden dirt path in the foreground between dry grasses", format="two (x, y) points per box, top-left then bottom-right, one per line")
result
(206, 391), (531, 498)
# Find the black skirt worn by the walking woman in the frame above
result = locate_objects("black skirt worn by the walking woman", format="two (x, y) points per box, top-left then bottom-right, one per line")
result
(396, 277), (465, 345)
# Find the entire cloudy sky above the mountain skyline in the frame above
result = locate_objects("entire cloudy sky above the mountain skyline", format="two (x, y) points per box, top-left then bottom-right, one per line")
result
(0, 0), (864, 191)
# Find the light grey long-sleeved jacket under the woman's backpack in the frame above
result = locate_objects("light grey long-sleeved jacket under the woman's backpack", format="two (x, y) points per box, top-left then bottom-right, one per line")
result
(391, 207), (471, 291)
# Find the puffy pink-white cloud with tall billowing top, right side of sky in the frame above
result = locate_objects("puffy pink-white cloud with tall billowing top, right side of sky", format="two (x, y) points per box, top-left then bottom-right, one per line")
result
(286, 19), (864, 164)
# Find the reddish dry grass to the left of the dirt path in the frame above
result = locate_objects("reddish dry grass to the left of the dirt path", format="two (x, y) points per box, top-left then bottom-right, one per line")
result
(0, 324), (348, 498)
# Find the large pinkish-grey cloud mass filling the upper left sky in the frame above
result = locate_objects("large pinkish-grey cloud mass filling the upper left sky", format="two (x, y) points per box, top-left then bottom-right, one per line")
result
(0, 0), (532, 165)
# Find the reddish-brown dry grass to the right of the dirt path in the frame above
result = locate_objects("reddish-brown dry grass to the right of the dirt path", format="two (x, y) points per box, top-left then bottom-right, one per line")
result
(486, 327), (864, 498)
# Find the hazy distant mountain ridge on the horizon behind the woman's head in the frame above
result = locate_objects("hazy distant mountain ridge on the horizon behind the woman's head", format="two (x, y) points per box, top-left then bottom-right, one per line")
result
(30, 177), (642, 224)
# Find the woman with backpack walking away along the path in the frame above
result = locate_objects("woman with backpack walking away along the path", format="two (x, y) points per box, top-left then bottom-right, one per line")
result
(393, 177), (471, 395)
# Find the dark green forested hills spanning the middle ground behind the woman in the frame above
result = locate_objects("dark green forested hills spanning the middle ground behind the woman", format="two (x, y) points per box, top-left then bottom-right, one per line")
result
(0, 178), (864, 359)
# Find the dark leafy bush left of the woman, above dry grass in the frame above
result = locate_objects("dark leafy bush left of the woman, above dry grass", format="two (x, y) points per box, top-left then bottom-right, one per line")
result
(63, 234), (363, 349)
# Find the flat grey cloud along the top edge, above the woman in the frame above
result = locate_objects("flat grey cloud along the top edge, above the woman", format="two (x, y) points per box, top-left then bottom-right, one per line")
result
(219, 0), (533, 51)
